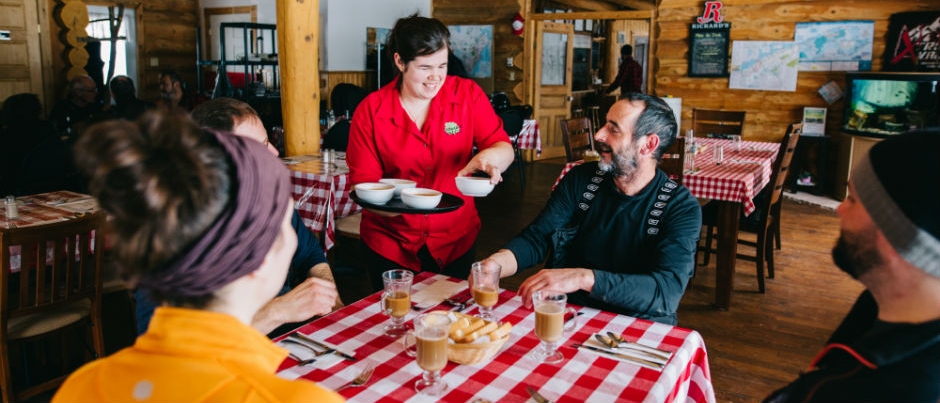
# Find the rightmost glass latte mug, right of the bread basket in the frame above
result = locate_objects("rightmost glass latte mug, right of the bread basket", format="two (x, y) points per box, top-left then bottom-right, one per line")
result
(529, 291), (578, 364)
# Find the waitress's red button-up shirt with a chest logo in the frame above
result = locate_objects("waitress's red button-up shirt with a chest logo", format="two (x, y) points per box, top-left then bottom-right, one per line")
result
(346, 76), (509, 271)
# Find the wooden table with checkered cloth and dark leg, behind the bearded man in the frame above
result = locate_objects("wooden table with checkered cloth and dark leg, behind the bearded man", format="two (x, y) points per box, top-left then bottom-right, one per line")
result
(555, 138), (780, 310)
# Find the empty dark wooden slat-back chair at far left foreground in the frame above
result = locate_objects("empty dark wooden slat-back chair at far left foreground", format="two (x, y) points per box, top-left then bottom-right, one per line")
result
(0, 212), (105, 402)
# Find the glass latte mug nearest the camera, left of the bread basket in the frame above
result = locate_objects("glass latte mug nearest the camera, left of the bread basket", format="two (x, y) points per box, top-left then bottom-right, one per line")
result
(402, 312), (453, 396)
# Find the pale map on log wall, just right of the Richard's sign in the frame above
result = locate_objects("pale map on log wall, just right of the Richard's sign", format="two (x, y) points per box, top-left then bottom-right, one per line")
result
(728, 41), (800, 91)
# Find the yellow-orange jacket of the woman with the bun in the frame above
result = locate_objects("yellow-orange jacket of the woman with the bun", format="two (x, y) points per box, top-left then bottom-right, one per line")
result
(52, 307), (344, 403)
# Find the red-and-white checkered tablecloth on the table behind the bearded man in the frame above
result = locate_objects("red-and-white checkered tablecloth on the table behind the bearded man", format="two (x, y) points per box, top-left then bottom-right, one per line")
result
(552, 138), (780, 215)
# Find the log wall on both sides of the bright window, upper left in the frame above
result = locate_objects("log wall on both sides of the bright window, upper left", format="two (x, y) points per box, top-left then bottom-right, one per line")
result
(45, 0), (199, 104)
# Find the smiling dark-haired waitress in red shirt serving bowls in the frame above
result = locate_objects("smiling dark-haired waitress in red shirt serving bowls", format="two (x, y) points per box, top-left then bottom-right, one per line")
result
(346, 15), (513, 290)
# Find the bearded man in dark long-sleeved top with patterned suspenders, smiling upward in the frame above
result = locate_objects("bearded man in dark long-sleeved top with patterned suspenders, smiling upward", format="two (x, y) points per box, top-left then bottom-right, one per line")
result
(484, 93), (702, 325)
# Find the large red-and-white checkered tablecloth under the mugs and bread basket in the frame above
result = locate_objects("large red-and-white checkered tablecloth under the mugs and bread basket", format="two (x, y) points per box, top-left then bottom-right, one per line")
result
(278, 273), (715, 403)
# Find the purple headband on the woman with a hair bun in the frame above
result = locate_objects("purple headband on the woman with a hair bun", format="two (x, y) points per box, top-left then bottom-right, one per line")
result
(140, 133), (291, 297)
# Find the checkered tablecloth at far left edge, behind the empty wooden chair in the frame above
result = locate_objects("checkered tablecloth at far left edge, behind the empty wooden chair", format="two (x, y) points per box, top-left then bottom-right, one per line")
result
(0, 190), (98, 273)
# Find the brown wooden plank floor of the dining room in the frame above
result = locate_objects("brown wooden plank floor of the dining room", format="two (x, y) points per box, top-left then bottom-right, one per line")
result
(477, 160), (862, 402)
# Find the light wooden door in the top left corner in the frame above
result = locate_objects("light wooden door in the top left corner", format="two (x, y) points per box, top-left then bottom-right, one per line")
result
(0, 0), (46, 104)
